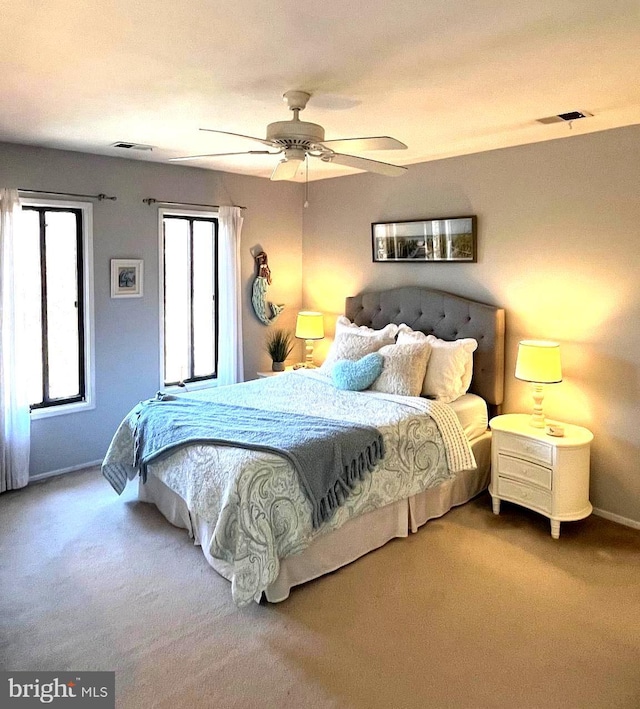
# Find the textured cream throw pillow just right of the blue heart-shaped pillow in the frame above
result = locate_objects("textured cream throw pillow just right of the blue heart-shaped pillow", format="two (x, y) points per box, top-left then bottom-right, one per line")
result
(371, 343), (431, 396)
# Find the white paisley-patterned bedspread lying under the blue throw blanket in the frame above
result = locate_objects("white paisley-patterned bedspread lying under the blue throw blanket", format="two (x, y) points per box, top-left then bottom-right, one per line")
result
(105, 370), (475, 605)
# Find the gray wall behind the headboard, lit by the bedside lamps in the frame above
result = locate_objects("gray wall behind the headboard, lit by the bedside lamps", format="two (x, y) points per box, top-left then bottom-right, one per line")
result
(303, 126), (640, 523)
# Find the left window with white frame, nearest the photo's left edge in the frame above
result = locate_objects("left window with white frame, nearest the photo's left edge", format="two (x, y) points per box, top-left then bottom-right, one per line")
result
(20, 200), (93, 416)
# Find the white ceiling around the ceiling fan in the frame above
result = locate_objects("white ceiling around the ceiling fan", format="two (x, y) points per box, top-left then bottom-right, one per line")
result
(0, 0), (640, 179)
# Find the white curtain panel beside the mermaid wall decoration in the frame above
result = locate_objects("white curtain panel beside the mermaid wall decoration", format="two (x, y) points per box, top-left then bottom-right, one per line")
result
(218, 207), (244, 384)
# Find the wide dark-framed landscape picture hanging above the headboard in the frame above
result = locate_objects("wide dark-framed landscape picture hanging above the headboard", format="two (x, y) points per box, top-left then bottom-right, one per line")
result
(371, 215), (478, 263)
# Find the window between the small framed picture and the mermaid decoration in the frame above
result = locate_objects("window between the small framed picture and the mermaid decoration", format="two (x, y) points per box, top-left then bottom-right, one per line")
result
(160, 211), (218, 386)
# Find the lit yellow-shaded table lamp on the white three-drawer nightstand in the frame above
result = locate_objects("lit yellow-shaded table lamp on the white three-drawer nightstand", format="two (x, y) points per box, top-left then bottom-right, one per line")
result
(516, 340), (562, 428)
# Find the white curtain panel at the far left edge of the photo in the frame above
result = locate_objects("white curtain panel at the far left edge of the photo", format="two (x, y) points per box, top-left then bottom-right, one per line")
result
(0, 188), (30, 492)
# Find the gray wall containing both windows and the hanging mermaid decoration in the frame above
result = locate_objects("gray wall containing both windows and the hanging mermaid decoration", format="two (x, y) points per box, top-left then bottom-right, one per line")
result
(0, 144), (303, 475)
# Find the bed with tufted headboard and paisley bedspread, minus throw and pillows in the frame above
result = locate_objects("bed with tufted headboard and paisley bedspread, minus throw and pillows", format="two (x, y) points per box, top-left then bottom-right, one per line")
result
(103, 287), (504, 606)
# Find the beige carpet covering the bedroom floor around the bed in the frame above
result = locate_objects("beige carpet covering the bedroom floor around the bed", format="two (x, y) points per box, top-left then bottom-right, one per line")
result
(0, 470), (640, 709)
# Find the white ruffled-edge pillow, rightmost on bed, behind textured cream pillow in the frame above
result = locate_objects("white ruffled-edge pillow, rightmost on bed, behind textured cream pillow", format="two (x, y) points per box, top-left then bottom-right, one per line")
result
(398, 325), (478, 404)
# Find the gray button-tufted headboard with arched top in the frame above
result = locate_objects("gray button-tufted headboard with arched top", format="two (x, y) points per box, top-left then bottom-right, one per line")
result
(345, 286), (504, 414)
